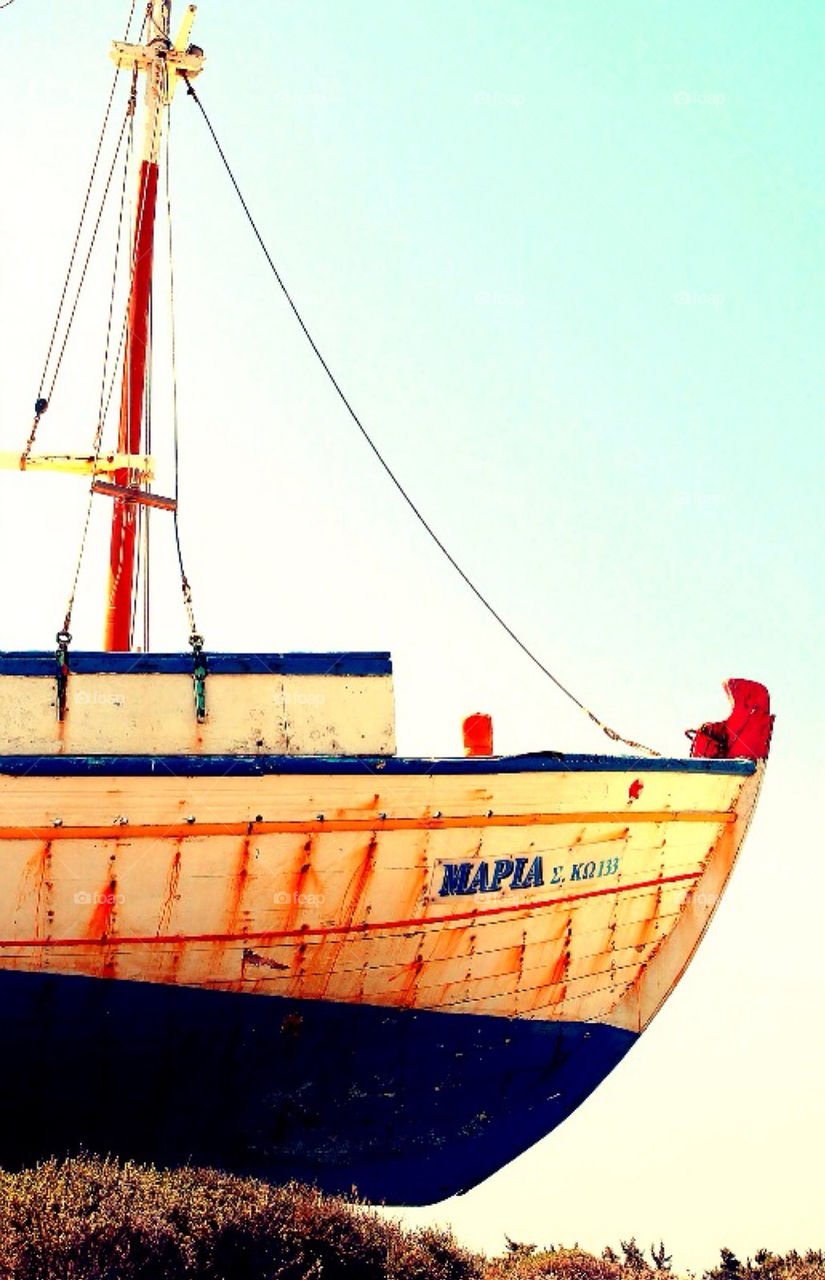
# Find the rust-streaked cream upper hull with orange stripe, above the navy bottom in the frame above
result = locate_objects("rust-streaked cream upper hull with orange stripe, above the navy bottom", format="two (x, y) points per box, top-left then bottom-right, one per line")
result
(0, 760), (764, 1030)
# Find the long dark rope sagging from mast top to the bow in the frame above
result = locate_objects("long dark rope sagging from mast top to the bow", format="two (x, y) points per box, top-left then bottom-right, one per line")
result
(180, 72), (660, 755)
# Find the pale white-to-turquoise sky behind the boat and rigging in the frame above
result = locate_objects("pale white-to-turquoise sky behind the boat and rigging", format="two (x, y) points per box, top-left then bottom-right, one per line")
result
(0, 0), (825, 1270)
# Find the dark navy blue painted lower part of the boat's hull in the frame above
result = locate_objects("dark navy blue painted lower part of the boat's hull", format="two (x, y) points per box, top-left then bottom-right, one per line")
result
(0, 972), (637, 1204)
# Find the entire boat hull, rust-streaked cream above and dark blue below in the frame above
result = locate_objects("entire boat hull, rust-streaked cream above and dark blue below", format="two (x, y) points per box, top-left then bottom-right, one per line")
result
(0, 754), (764, 1203)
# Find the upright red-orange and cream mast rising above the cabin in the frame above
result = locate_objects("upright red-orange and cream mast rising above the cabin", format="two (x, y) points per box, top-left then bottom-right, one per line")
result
(104, 0), (203, 650)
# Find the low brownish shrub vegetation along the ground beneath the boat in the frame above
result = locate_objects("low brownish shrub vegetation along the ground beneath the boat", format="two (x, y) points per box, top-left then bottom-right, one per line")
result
(0, 1157), (825, 1280)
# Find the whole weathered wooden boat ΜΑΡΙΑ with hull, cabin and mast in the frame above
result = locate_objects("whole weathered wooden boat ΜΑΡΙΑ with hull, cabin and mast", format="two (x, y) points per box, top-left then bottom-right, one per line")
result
(0, 0), (773, 1203)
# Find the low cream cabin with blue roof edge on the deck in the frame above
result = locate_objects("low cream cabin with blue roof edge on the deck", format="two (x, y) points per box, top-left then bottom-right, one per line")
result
(0, 652), (395, 755)
